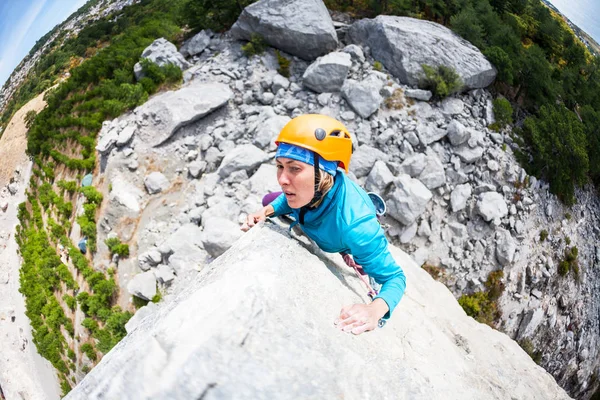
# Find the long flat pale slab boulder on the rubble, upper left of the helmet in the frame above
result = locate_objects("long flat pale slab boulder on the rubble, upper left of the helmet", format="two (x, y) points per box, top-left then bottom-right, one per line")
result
(137, 83), (233, 146)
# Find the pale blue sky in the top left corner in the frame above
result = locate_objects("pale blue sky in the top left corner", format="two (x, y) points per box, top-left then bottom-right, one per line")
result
(0, 0), (87, 87)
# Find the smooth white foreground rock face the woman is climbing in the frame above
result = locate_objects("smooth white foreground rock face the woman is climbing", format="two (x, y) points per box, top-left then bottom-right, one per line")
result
(65, 225), (569, 400)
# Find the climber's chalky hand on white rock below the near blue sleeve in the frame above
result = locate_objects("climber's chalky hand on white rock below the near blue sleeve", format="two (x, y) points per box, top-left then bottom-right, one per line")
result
(334, 298), (389, 335)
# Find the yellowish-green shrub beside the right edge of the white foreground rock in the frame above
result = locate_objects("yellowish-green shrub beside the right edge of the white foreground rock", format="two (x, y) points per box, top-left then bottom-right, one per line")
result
(458, 270), (504, 327)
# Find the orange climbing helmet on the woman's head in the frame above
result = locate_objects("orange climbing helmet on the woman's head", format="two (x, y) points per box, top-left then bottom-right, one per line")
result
(275, 114), (352, 172)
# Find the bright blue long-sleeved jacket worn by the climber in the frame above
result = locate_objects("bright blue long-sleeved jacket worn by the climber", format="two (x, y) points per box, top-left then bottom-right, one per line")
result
(271, 170), (406, 319)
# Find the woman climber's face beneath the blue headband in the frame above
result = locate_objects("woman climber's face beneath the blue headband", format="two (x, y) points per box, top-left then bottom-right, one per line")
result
(277, 157), (315, 208)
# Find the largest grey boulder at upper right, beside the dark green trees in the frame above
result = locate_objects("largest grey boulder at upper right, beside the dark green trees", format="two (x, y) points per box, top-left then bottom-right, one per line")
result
(348, 15), (496, 89)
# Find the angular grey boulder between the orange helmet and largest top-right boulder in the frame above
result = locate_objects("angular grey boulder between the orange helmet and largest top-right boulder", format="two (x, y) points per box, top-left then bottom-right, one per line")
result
(342, 77), (383, 118)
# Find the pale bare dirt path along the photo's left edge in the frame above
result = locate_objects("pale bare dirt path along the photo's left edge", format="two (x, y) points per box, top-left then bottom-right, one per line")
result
(0, 95), (60, 400)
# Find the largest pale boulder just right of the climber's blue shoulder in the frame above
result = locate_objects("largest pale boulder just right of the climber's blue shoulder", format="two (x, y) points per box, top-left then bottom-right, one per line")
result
(387, 174), (433, 225)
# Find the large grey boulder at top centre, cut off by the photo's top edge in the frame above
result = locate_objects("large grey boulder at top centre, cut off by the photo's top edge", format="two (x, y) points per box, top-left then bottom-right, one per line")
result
(230, 0), (338, 60)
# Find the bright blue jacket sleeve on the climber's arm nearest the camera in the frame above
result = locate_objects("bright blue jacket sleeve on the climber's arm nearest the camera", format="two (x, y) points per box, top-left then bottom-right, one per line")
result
(345, 216), (406, 319)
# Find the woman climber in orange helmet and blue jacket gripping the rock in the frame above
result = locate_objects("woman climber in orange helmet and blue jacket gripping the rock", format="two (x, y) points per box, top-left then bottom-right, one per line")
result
(241, 114), (406, 335)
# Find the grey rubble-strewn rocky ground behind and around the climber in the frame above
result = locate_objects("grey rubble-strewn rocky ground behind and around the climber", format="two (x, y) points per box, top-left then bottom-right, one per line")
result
(88, 10), (598, 393)
